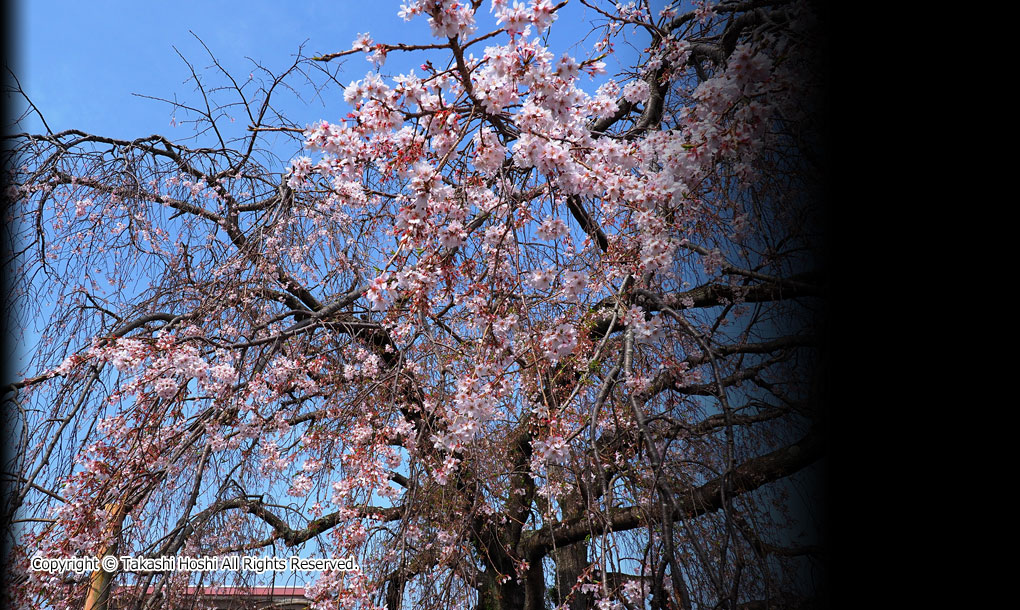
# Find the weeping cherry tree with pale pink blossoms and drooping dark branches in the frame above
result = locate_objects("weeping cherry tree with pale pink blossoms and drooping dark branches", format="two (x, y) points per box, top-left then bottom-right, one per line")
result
(4, 0), (826, 609)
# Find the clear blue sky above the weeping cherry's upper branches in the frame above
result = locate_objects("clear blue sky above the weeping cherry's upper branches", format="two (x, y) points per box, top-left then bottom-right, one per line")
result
(11, 0), (640, 139)
